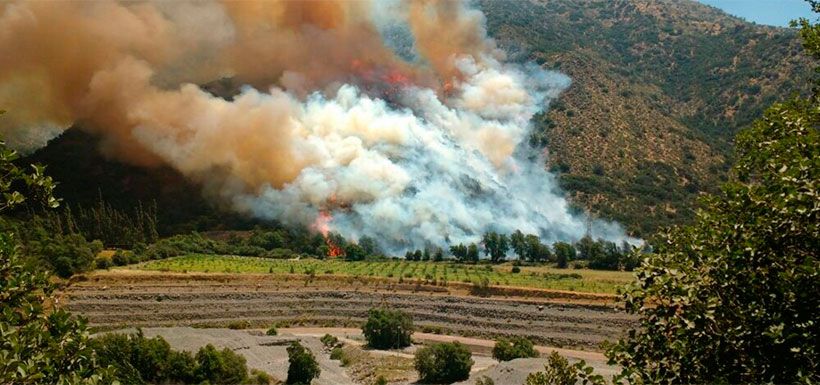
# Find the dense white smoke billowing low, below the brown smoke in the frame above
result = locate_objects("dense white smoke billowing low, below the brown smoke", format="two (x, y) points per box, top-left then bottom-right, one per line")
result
(234, 57), (626, 252)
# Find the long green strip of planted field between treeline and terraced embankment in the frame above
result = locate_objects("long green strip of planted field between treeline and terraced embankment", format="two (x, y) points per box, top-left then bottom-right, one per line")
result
(131, 254), (633, 293)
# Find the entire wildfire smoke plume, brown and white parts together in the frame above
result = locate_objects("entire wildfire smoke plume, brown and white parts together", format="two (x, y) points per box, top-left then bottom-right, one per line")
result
(0, 0), (636, 251)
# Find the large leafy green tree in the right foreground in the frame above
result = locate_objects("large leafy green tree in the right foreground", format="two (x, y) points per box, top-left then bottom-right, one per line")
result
(608, 15), (820, 384)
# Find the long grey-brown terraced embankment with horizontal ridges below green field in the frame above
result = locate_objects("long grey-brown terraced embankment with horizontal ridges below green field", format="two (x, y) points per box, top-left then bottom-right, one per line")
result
(63, 271), (633, 351)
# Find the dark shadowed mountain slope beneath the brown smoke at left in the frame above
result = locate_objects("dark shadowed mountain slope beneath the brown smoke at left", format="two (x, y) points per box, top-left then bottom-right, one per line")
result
(20, 127), (255, 235)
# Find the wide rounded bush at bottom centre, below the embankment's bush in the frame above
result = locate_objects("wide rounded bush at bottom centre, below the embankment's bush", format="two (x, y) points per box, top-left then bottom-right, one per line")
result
(413, 342), (473, 384)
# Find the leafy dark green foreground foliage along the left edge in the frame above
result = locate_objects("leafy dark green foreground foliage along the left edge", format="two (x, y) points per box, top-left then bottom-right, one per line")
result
(0, 124), (112, 385)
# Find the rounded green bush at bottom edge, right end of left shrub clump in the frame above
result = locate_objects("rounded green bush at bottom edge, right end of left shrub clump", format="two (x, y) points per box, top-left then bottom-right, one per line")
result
(194, 344), (248, 385)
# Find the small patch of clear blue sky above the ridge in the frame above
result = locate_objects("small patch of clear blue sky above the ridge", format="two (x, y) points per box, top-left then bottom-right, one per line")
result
(699, 0), (816, 27)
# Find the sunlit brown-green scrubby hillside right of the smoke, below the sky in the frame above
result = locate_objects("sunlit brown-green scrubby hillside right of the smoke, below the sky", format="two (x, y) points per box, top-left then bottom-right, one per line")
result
(479, 0), (810, 236)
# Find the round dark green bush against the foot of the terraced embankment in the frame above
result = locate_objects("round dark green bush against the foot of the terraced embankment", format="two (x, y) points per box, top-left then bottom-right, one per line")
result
(362, 309), (413, 349)
